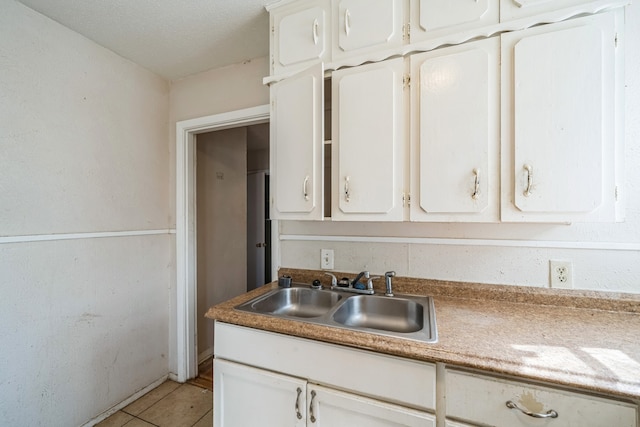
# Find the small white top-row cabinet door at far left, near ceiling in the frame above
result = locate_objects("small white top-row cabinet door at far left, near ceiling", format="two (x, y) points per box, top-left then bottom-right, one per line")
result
(270, 0), (331, 74)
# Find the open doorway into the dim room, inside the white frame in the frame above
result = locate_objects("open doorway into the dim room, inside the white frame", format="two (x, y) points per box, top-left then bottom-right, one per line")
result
(196, 123), (271, 364)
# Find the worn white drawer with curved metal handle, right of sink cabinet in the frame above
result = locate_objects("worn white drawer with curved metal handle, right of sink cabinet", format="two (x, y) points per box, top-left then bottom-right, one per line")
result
(445, 369), (638, 427)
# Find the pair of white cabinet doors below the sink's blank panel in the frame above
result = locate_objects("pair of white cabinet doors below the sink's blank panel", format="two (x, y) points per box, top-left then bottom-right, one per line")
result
(214, 359), (436, 427)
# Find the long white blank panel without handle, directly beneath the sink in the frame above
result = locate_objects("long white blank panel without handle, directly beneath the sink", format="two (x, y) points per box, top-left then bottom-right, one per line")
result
(214, 322), (436, 411)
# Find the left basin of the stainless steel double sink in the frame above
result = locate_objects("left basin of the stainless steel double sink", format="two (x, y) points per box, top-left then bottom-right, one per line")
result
(239, 288), (342, 318)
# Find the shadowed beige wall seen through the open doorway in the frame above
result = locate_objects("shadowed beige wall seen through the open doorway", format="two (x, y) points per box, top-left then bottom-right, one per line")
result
(196, 128), (247, 355)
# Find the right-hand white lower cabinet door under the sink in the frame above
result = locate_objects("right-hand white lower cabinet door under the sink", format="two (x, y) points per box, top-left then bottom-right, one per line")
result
(307, 385), (436, 427)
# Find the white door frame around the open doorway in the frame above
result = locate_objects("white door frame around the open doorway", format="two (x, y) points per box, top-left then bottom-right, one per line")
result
(175, 104), (277, 382)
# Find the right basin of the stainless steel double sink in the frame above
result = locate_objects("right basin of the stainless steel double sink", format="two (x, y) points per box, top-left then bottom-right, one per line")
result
(333, 295), (424, 333)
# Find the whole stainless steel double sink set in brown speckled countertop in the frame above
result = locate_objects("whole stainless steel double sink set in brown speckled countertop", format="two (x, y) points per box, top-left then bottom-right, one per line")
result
(235, 284), (437, 343)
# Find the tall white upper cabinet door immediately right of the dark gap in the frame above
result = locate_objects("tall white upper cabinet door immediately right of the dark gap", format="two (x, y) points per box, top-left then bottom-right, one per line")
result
(332, 58), (405, 221)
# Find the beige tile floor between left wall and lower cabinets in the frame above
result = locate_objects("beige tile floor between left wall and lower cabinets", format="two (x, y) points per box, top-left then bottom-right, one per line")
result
(96, 381), (213, 427)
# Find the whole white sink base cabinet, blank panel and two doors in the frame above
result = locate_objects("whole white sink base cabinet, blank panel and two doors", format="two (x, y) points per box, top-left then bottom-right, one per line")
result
(213, 322), (436, 427)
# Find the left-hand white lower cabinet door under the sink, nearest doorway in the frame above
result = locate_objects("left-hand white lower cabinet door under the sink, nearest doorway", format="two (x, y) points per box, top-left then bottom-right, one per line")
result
(213, 359), (307, 427)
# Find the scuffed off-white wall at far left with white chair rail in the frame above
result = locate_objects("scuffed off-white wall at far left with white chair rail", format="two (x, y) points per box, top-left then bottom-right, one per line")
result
(0, 0), (173, 426)
